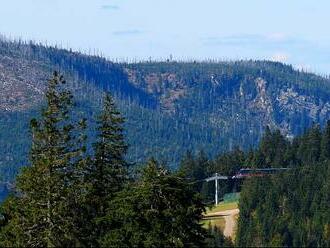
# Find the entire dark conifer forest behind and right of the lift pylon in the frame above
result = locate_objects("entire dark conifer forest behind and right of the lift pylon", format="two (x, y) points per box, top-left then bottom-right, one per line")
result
(181, 124), (330, 247)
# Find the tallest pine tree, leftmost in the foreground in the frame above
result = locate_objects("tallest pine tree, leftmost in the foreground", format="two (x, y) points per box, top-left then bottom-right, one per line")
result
(1, 72), (84, 247)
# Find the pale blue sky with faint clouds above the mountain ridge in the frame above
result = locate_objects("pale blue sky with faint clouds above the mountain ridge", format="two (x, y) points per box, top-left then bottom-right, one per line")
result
(0, 0), (330, 74)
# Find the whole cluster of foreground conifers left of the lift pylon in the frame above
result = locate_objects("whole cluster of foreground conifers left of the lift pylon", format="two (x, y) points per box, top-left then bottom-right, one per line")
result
(0, 77), (214, 247)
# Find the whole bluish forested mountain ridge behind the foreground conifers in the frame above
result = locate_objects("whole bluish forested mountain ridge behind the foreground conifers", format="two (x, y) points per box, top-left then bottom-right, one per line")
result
(0, 41), (330, 182)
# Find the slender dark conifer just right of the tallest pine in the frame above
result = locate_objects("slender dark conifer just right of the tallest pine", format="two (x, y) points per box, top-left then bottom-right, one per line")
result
(86, 93), (128, 244)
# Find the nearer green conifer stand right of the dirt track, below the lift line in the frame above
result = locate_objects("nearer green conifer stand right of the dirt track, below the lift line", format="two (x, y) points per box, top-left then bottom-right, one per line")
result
(237, 165), (330, 247)
